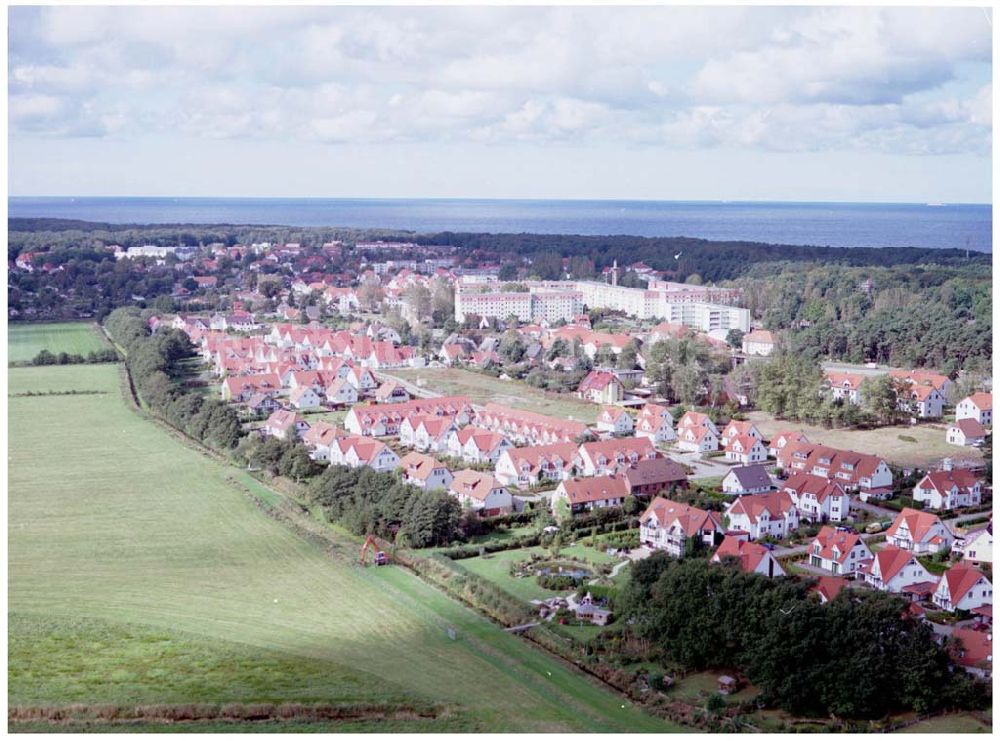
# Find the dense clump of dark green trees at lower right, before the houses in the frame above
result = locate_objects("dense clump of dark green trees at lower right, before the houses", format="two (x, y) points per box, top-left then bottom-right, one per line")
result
(617, 553), (990, 719)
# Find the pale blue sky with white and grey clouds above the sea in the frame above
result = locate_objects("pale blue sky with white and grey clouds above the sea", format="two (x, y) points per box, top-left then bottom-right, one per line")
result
(8, 6), (992, 203)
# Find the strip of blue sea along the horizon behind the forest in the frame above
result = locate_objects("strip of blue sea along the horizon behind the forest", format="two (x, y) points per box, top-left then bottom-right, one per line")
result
(8, 197), (993, 252)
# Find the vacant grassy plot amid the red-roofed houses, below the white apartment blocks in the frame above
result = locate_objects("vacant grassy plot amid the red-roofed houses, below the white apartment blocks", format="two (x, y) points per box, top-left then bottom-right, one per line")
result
(390, 368), (600, 424)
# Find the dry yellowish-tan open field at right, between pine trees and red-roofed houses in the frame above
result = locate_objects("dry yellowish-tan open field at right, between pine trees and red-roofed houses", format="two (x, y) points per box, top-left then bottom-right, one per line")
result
(747, 412), (983, 468)
